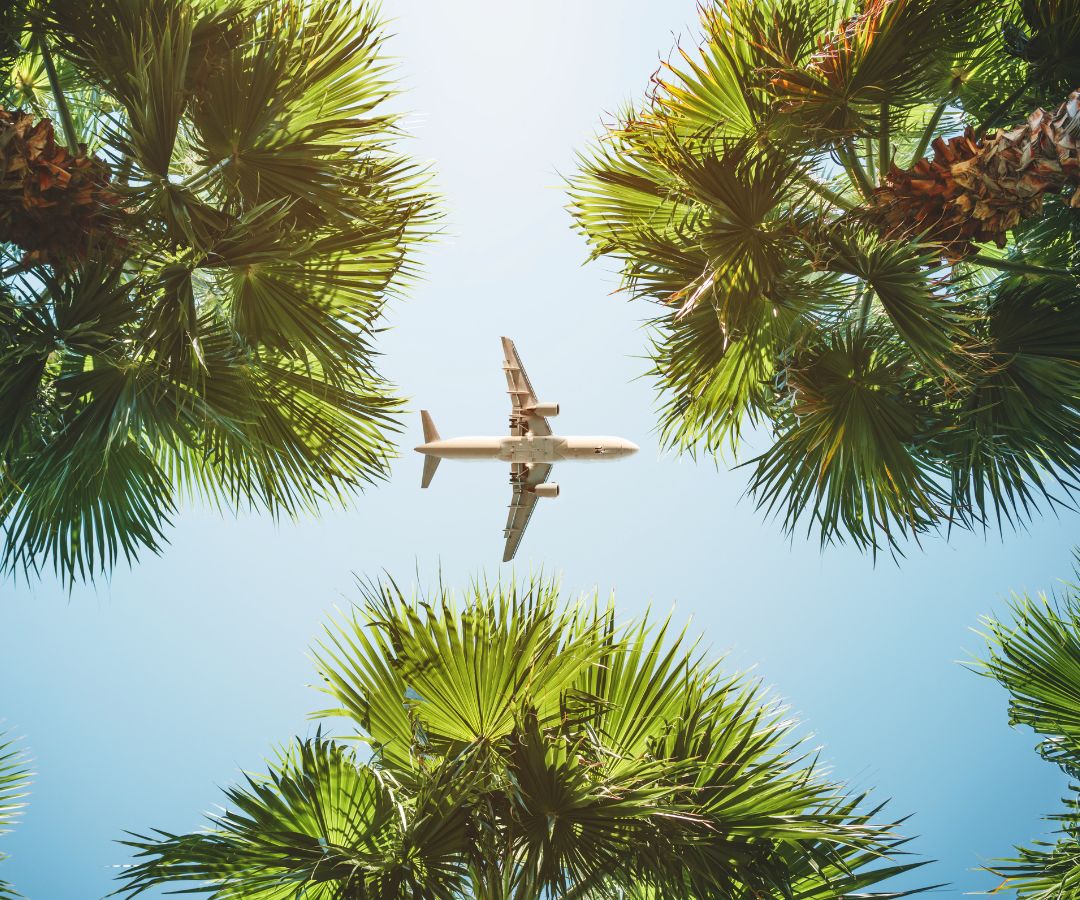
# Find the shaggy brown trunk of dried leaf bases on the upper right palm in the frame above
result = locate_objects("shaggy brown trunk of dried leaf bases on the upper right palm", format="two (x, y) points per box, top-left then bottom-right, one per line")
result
(870, 91), (1080, 260)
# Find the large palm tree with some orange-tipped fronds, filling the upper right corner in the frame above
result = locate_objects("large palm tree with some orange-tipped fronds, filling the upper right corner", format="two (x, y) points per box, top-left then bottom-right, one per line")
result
(571, 0), (1080, 552)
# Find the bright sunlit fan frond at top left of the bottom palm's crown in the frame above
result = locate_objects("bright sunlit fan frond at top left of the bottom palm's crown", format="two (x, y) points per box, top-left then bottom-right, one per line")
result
(316, 579), (599, 754)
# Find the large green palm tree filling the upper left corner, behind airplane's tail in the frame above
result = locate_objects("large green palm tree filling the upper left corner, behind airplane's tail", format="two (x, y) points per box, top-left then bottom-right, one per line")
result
(0, 0), (432, 582)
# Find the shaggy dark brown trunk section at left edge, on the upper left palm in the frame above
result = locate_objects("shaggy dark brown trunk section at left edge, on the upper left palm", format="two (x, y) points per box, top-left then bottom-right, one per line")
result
(0, 109), (117, 266)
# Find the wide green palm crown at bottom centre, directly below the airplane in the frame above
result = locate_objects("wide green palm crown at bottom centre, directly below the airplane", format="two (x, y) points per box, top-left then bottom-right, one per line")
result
(119, 579), (921, 900)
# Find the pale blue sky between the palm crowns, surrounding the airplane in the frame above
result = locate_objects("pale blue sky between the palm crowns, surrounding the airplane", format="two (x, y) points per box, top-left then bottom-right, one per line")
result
(0, 0), (1080, 900)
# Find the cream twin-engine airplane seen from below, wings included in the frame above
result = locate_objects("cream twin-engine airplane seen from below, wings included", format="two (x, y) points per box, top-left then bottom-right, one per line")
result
(416, 337), (637, 563)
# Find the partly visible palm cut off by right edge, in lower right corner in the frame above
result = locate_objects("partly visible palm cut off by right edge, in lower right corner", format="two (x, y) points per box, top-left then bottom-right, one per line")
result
(980, 554), (1080, 900)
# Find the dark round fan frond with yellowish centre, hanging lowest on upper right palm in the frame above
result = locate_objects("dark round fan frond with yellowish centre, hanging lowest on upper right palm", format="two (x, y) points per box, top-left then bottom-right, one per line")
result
(750, 328), (948, 551)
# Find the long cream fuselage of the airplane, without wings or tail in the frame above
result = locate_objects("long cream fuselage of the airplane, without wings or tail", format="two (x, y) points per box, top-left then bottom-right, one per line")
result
(416, 434), (637, 464)
